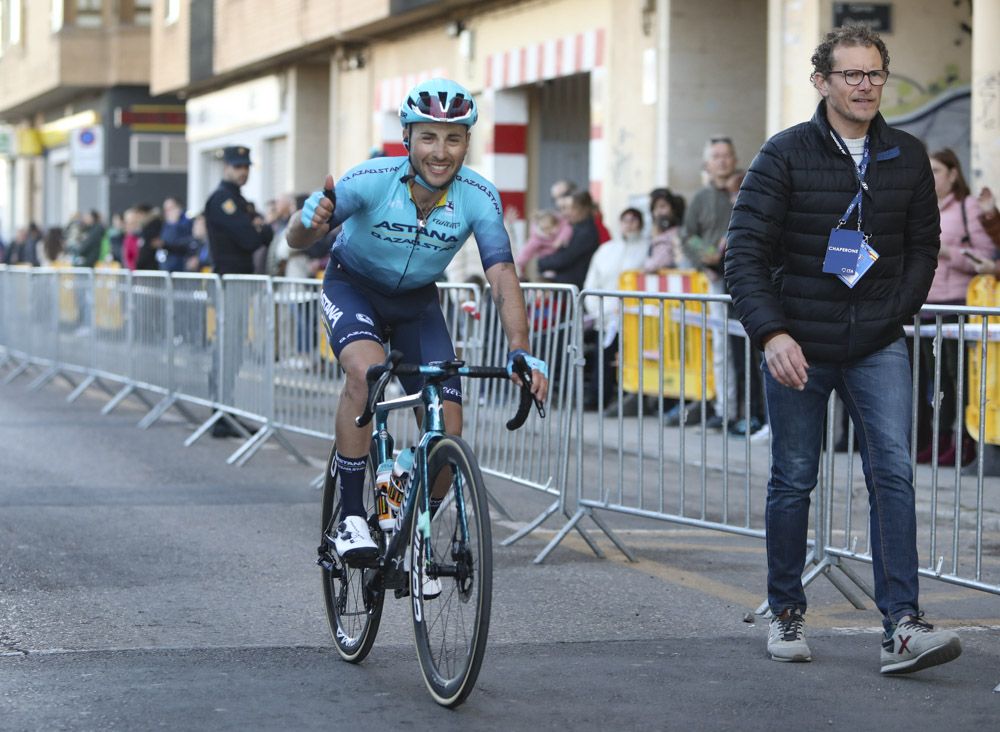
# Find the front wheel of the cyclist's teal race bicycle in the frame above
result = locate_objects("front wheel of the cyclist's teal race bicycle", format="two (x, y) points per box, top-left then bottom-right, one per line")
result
(410, 436), (493, 707)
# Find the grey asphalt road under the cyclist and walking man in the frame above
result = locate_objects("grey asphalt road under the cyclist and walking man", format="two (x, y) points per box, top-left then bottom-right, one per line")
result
(0, 376), (1000, 732)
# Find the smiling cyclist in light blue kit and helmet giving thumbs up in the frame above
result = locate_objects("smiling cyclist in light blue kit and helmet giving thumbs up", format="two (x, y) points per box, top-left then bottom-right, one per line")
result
(287, 79), (548, 562)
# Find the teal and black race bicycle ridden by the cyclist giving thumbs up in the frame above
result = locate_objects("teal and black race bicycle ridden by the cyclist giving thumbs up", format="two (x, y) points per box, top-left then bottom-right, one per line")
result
(317, 351), (544, 707)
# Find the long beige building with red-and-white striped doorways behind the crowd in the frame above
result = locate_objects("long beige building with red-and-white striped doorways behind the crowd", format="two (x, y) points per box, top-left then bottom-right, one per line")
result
(0, 0), (1000, 262)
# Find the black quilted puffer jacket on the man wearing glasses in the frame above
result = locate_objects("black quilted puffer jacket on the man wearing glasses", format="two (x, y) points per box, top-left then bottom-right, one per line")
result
(726, 102), (940, 363)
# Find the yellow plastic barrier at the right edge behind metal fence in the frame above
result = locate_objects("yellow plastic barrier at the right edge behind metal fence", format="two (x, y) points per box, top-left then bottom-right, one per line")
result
(965, 275), (1000, 445)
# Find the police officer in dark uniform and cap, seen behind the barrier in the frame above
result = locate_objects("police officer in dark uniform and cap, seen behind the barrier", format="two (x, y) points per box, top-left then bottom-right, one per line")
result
(205, 145), (272, 275)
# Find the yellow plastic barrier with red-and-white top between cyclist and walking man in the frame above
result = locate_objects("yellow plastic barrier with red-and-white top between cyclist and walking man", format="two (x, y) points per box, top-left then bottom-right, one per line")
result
(618, 270), (715, 399)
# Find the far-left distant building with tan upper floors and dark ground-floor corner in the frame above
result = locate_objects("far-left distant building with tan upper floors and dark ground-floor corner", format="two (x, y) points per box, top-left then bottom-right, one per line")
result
(0, 0), (187, 237)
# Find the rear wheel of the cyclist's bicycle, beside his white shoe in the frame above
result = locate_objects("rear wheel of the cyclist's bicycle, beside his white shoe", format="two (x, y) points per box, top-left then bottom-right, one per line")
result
(320, 443), (385, 663)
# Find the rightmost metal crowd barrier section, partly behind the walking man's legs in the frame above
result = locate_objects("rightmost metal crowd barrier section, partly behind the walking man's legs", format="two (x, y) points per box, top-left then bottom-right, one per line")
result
(806, 302), (1000, 607)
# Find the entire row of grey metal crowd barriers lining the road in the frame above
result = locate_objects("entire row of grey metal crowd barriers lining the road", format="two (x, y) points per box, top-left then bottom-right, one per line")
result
(0, 267), (1000, 604)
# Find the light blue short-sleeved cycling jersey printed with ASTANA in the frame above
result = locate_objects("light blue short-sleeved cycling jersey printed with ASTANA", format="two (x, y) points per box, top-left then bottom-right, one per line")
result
(330, 157), (514, 295)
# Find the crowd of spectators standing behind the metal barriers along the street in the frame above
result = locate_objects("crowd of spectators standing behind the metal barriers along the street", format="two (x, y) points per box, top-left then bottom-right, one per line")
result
(7, 136), (1000, 452)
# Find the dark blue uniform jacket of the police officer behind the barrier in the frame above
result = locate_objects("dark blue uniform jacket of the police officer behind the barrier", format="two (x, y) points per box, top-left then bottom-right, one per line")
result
(205, 181), (273, 274)
